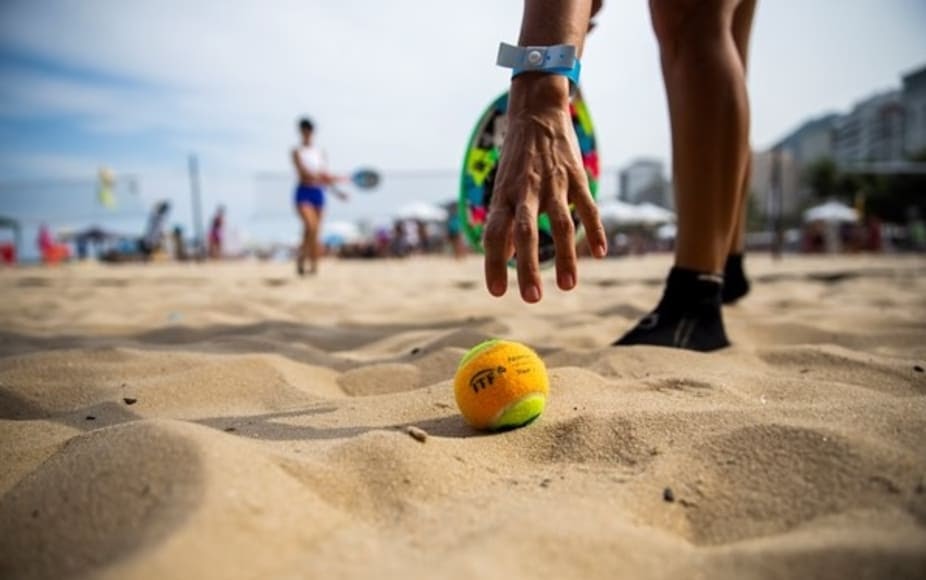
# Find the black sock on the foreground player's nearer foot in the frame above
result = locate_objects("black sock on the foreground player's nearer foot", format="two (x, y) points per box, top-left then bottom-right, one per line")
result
(614, 267), (730, 352)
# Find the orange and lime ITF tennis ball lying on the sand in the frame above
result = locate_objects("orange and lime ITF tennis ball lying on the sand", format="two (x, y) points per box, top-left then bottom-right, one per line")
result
(453, 339), (550, 430)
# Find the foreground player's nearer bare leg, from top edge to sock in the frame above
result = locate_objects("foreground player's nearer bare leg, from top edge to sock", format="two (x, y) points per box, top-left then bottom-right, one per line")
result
(650, 0), (749, 274)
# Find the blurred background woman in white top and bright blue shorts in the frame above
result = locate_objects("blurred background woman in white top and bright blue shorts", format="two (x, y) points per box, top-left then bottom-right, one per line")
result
(292, 119), (347, 276)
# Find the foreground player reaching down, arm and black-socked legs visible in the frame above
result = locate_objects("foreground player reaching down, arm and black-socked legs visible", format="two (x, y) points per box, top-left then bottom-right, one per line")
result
(485, 0), (756, 351)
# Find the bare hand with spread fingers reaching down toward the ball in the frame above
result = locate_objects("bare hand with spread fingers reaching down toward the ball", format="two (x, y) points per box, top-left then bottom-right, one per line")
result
(484, 75), (607, 302)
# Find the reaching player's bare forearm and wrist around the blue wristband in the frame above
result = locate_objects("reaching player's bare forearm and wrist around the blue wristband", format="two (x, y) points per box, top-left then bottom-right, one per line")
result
(510, 0), (592, 114)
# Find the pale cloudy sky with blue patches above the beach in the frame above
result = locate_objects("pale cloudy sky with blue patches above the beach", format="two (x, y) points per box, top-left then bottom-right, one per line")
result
(0, 0), (926, 247)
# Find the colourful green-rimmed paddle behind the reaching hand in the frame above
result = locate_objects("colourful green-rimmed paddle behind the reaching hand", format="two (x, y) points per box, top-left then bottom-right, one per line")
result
(459, 91), (600, 265)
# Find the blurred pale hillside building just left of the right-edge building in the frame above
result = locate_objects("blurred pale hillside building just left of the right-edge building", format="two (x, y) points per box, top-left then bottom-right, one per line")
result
(833, 91), (904, 166)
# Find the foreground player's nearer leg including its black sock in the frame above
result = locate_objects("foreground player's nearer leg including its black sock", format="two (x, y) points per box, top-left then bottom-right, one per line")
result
(615, 0), (749, 351)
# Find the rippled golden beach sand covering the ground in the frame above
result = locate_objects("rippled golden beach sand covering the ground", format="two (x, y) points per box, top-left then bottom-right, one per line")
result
(0, 256), (926, 579)
